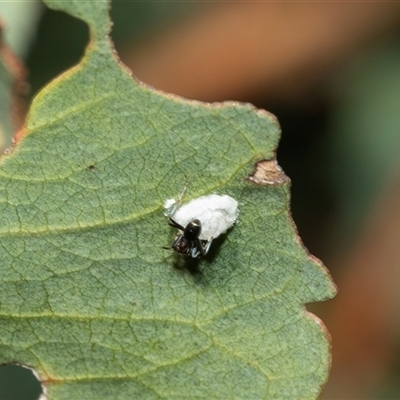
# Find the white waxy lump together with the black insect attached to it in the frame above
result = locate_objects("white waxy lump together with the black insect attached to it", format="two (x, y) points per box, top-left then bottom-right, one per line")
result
(164, 191), (239, 258)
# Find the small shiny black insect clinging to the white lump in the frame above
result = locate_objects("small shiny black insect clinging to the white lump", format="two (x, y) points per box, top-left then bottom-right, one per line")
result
(164, 217), (212, 258)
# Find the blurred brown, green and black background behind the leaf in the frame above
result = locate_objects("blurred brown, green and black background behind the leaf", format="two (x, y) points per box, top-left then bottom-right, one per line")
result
(0, 0), (400, 400)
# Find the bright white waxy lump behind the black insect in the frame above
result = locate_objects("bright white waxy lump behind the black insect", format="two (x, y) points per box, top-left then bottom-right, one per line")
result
(164, 194), (239, 240)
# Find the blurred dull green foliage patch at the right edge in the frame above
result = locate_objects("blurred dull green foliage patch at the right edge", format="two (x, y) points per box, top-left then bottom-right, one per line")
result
(331, 39), (400, 237)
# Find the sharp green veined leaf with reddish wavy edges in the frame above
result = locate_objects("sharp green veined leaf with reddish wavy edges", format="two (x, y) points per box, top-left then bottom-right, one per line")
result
(0, 0), (335, 400)
